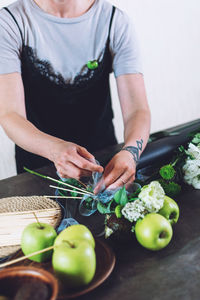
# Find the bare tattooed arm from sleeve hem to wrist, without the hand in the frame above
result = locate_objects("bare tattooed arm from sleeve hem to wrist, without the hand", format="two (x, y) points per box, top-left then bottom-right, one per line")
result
(117, 74), (151, 158)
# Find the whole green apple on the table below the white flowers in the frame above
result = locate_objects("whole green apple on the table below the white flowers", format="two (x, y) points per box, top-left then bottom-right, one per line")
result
(135, 213), (173, 250)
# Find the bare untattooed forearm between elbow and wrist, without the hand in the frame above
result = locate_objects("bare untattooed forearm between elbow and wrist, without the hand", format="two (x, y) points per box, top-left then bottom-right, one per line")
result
(0, 112), (59, 160)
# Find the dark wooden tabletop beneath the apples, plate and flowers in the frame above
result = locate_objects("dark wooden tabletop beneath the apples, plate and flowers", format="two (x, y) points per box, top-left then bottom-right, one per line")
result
(0, 138), (200, 300)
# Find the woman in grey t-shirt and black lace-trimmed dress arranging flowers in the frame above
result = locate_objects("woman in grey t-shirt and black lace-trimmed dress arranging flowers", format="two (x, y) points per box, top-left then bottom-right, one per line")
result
(0, 0), (150, 192)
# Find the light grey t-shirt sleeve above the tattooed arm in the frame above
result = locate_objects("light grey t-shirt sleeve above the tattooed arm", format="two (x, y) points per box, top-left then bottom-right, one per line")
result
(110, 9), (143, 77)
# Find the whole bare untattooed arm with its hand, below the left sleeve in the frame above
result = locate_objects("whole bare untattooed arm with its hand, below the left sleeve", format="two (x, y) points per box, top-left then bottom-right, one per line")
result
(0, 73), (103, 179)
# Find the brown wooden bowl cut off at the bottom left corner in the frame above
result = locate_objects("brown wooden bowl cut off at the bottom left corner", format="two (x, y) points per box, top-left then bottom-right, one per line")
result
(0, 266), (58, 300)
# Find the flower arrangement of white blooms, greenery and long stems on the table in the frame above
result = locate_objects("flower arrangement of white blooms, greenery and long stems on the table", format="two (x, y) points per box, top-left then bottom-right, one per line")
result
(23, 133), (200, 243)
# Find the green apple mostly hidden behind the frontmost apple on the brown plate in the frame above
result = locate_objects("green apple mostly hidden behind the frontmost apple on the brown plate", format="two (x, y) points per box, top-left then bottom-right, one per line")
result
(54, 224), (95, 248)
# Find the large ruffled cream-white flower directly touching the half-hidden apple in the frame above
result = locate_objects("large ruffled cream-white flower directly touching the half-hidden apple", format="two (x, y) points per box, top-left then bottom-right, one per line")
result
(138, 181), (165, 213)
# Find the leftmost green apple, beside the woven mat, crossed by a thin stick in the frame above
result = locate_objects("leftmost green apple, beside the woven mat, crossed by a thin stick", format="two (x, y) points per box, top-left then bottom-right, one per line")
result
(21, 223), (57, 262)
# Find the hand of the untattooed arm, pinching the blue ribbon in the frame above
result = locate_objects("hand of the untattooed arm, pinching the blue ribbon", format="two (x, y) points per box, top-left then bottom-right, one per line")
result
(50, 140), (103, 179)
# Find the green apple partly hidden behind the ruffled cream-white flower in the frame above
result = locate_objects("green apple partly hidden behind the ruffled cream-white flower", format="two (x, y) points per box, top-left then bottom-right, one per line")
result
(158, 196), (179, 225)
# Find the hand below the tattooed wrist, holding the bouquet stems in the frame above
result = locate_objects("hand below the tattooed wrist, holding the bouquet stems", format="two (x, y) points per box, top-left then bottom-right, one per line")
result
(94, 151), (136, 194)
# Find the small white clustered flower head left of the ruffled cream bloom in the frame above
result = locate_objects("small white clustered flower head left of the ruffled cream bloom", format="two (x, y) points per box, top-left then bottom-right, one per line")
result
(121, 199), (145, 222)
